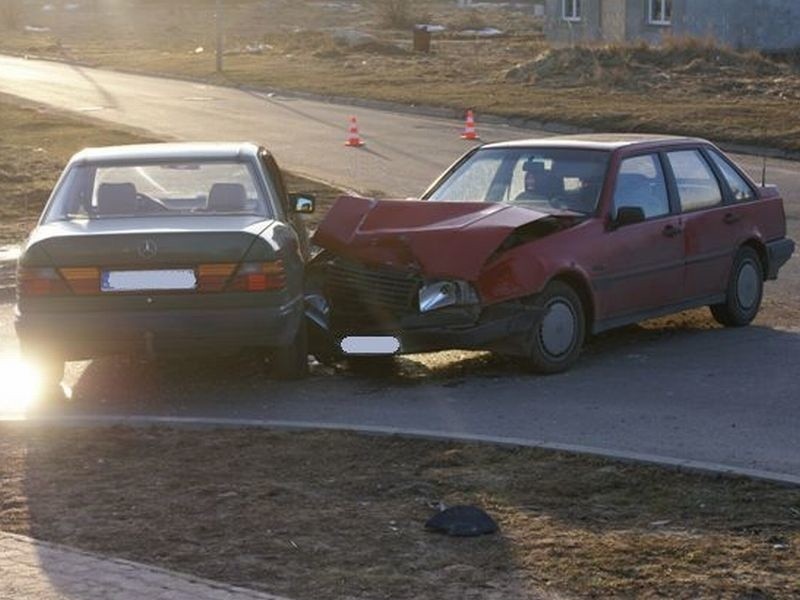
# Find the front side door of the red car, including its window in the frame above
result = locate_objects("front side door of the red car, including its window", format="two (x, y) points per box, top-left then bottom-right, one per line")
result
(591, 152), (684, 320)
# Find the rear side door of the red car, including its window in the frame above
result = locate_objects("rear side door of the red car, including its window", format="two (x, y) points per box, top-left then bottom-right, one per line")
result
(666, 148), (742, 300)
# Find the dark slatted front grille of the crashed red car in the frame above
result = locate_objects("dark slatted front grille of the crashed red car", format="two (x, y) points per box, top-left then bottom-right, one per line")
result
(325, 259), (422, 332)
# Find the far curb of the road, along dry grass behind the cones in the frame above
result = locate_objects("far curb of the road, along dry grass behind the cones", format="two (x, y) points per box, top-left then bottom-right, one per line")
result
(6, 51), (800, 161)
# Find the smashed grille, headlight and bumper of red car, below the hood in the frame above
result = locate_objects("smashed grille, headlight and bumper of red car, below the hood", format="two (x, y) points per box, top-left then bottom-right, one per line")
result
(306, 253), (539, 354)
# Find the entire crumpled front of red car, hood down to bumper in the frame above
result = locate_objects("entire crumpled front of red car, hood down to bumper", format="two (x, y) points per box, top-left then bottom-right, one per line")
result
(306, 198), (580, 354)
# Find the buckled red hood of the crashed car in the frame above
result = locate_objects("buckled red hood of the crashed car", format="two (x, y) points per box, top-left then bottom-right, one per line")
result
(313, 196), (575, 281)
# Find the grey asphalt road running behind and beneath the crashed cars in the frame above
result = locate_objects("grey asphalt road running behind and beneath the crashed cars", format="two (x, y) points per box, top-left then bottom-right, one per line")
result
(0, 57), (800, 478)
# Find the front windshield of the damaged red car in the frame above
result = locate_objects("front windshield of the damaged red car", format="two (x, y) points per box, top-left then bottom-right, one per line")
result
(425, 148), (609, 214)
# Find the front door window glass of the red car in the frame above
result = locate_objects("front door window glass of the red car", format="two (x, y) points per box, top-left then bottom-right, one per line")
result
(614, 154), (669, 219)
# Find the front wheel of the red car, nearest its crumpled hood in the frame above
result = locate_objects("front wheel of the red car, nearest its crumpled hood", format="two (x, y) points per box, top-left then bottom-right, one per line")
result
(530, 281), (586, 375)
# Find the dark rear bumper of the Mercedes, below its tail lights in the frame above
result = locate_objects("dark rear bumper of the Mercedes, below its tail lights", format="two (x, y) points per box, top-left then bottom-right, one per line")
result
(14, 299), (303, 360)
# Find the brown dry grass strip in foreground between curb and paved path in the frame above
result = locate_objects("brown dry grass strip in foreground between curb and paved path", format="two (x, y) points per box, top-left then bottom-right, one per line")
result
(0, 426), (800, 600)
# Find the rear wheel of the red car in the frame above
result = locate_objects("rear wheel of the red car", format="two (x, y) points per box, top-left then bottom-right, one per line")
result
(710, 246), (764, 327)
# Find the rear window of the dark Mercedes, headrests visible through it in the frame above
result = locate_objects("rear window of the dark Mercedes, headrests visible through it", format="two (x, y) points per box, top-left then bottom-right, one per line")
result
(44, 161), (275, 223)
